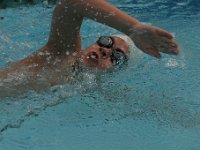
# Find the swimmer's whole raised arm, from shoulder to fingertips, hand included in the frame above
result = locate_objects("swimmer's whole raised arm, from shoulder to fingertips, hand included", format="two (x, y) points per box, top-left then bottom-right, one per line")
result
(48, 0), (179, 58)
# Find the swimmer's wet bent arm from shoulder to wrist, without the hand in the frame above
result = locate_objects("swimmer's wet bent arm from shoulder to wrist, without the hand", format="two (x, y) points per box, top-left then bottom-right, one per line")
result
(48, 0), (139, 53)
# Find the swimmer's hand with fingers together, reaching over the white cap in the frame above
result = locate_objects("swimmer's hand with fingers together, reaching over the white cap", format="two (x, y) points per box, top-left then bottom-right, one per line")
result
(129, 23), (179, 58)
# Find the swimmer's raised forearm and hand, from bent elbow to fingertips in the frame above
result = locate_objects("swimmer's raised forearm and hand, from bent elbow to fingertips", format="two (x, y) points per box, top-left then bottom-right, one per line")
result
(58, 0), (179, 58)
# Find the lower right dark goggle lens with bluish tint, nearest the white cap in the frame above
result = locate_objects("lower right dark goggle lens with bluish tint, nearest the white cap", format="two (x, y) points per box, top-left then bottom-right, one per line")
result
(110, 49), (128, 66)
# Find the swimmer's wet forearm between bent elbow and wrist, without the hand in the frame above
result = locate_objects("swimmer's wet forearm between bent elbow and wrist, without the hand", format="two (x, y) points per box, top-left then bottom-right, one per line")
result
(61, 0), (140, 35)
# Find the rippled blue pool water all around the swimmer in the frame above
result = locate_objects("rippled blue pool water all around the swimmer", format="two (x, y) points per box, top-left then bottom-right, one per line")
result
(0, 0), (200, 150)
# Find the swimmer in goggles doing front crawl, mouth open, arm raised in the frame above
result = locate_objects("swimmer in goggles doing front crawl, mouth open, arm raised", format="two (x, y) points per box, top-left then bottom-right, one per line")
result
(0, 0), (179, 96)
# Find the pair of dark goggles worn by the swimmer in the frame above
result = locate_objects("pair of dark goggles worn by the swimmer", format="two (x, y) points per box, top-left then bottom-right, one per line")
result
(97, 36), (128, 66)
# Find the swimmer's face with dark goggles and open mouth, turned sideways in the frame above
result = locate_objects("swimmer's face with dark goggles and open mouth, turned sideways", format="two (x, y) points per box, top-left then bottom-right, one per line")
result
(81, 36), (130, 70)
